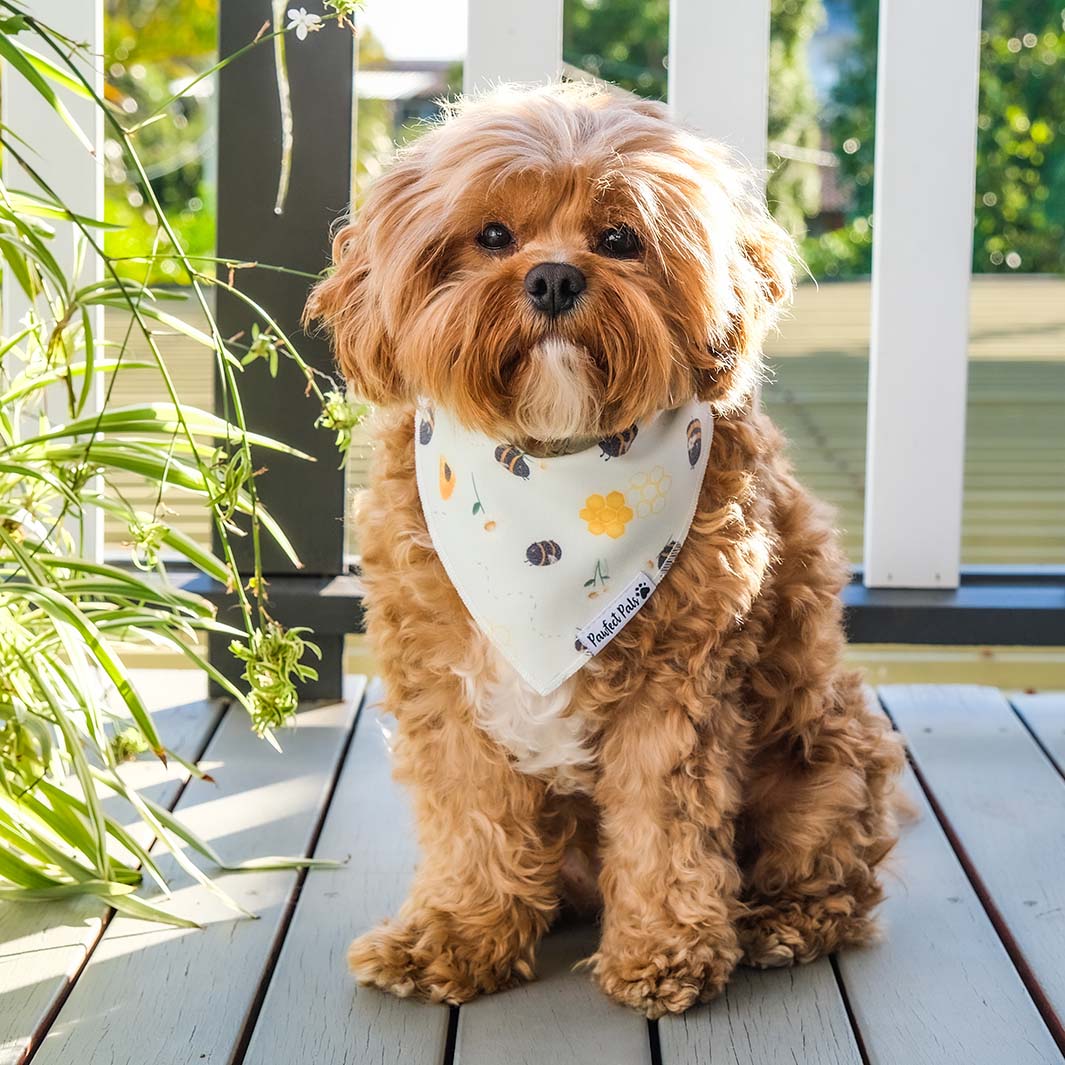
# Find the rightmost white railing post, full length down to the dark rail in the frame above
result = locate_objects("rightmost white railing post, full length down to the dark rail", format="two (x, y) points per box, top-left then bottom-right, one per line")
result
(865, 0), (980, 588)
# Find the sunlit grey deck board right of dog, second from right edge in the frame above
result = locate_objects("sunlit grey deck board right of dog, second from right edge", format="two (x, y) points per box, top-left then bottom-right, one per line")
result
(880, 686), (1065, 1043)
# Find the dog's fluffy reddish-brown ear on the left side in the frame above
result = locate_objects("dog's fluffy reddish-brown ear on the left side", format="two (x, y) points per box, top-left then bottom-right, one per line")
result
(304, 164), (416, 406)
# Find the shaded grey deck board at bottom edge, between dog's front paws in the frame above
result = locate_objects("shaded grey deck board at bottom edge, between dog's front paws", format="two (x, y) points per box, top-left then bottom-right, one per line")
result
(455, 924), (651, 1065)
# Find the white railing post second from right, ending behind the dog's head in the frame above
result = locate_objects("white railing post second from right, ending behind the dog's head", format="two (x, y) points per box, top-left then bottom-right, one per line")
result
(668, 0), (769, 173)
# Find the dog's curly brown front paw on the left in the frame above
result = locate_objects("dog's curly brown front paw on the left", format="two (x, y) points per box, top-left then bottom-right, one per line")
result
(347, 913), (533, 1005)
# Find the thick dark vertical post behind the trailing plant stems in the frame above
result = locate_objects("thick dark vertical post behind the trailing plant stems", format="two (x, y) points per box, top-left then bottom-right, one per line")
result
(211, 0), (357, 699)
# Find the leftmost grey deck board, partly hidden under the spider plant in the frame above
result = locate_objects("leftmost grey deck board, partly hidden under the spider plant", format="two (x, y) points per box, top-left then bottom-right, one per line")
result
(0, 699), (223, 1065)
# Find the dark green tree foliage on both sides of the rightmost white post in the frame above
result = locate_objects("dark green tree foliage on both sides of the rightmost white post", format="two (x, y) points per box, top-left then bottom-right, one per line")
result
(805, 0), (1065, 276)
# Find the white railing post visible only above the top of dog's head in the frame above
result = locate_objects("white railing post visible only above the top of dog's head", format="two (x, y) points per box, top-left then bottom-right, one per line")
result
(462, 0), (562, 93)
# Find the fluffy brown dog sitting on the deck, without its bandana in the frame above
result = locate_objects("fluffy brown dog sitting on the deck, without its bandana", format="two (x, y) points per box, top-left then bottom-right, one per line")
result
(309, 85), (901, 1017)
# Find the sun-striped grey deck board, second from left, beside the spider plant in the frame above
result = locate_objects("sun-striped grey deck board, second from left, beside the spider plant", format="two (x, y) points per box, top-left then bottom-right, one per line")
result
(34, 683), (363, 1065)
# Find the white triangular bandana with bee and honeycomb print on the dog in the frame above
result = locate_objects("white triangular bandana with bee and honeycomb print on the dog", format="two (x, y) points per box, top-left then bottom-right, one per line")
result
(414, 400), (714, 694)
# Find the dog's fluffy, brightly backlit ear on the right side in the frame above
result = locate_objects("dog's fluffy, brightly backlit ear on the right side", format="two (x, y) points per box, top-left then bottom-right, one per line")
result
(697, 203), (796, 412)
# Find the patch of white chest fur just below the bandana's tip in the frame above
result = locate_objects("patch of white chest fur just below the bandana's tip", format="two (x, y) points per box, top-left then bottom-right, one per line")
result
(464, 633), (593, 792)
